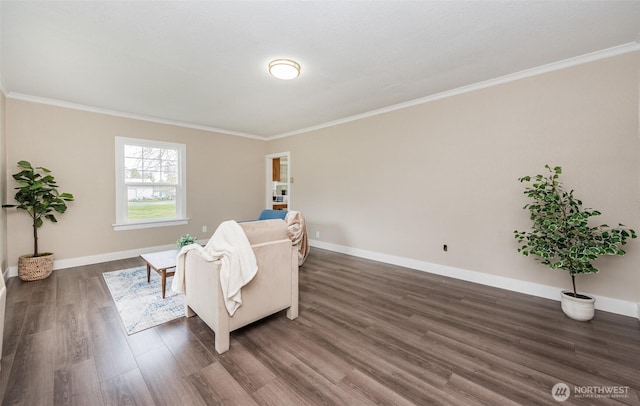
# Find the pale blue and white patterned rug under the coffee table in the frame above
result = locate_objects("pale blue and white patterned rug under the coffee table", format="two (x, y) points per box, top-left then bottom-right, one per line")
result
(102, 266), (184, 335)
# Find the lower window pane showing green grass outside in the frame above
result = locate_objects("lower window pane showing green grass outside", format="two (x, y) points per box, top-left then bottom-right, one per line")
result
(127, 186), (177, 220)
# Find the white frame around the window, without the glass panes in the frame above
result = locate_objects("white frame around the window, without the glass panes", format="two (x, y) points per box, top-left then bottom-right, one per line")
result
(113, 137), (189, 231)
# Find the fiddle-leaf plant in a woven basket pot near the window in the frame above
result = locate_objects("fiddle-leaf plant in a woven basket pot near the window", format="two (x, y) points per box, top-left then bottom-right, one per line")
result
(2, 161), (73, 281)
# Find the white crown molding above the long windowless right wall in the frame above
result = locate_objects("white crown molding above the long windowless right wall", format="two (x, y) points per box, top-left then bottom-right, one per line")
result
(267, 41), (640, 140)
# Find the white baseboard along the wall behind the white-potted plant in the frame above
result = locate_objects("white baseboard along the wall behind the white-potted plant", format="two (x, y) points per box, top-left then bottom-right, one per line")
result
(309, 240), (640, 320)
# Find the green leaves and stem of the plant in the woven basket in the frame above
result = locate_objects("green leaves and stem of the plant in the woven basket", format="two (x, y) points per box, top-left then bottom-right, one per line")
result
(2, 161), (73, 257)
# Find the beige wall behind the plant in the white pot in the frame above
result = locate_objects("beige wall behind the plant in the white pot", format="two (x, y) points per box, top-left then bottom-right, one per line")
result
(268, 52), (640, 302)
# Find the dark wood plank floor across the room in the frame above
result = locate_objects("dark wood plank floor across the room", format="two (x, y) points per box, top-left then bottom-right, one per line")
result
(0, 249), (640, 406)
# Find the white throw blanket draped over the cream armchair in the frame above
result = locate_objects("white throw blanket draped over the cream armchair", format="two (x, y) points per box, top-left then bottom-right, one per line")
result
(171, 220), (258, 316)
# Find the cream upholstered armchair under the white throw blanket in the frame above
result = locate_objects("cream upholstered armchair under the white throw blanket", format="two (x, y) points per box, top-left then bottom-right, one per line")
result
(185, 220), (298, 354)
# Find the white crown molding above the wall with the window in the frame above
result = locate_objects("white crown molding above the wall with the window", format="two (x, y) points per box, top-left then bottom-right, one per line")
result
(5, 92), (266, 141)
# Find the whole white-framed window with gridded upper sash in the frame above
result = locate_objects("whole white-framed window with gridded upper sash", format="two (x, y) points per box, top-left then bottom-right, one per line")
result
(114, 137), (188, 230)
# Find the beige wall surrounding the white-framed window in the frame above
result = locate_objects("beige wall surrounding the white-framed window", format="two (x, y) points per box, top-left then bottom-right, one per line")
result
(6, 98), (266, 265)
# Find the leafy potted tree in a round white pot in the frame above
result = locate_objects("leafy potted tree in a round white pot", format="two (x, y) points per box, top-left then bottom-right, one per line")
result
(514, 165), (636, 321)
